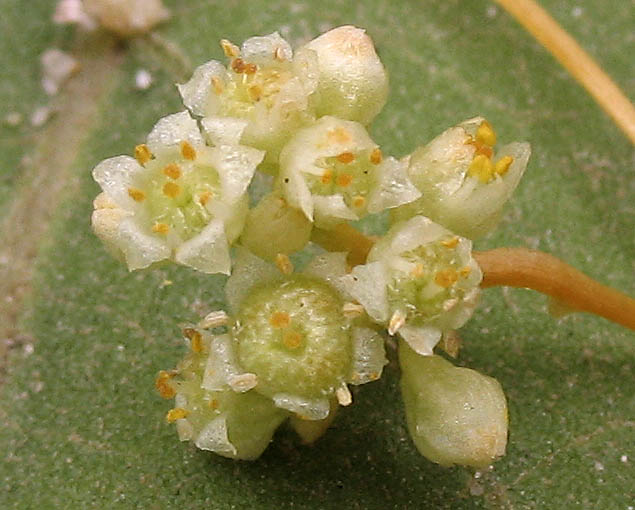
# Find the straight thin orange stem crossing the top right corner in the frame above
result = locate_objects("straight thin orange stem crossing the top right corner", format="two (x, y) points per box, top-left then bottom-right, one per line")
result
(496, 0), (635, 143)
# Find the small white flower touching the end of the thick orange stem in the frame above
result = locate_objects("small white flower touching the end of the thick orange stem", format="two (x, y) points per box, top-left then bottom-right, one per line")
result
(340, 216), (482, 355)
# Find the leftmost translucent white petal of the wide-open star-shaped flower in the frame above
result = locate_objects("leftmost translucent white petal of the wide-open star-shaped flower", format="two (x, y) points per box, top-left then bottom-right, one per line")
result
(93, 156), (145, 210)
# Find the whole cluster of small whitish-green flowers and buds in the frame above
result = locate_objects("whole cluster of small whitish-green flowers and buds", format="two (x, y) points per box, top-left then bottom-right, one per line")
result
(92, 26), (529, 466)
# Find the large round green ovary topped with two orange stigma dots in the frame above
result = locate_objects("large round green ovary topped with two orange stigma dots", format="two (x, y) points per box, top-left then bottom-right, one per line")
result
(234, 275), (351, 398)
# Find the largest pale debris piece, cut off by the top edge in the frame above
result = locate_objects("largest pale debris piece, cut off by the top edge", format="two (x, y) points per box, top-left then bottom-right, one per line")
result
(84, 0), (170, 37)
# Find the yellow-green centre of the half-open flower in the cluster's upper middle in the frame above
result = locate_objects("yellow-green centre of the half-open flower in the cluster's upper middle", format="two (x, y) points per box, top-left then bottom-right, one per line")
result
(307, 150), (373, 211)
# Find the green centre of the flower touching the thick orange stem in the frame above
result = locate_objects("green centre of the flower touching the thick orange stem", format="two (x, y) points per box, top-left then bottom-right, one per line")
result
(388, 237), (469, 322)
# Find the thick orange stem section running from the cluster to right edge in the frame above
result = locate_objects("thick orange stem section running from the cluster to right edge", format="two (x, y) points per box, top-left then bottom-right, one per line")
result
(473, 248), (635, 330)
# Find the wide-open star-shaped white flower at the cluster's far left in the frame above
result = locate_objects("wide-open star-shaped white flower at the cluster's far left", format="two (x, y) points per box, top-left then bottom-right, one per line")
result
(93, 112), (263, 274)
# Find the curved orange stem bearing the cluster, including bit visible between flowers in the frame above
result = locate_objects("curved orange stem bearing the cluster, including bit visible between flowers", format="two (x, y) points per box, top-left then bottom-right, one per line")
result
(311, 224), (635, 330)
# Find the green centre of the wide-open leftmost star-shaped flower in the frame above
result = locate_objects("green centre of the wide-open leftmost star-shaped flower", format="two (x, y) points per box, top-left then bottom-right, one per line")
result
(140, 159), (220, 240)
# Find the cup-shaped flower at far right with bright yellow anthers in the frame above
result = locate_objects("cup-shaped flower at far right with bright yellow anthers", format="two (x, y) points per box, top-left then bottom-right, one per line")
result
(393, 117), (531, 239)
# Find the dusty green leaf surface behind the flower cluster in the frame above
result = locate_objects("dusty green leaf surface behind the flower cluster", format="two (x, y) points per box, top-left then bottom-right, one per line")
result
(0, 0), (635, 510)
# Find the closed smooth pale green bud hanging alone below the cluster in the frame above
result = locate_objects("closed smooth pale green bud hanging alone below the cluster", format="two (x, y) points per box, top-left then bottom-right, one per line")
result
(399, 341), (508, 468)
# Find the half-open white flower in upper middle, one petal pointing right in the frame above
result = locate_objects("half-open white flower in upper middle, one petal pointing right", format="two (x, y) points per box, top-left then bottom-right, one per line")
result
(277, 116), (421, 228)
